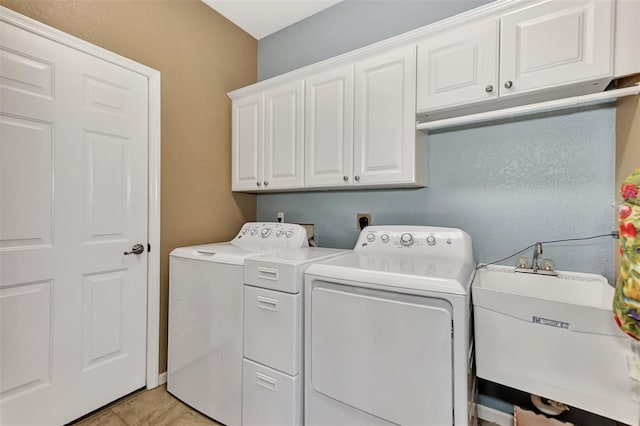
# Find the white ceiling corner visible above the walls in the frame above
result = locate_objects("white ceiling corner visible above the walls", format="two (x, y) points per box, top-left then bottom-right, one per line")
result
(202, 0), (342, 40)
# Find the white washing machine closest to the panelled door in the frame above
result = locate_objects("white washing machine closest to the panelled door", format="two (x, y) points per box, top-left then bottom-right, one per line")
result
(167, 223), (308, 425)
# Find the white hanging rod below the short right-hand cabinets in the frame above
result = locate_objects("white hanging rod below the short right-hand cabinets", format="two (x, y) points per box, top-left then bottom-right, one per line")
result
(416, 83), (640, 130)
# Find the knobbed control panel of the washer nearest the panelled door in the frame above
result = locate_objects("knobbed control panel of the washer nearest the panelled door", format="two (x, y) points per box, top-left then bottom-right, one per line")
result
(233, 222), (309, 248)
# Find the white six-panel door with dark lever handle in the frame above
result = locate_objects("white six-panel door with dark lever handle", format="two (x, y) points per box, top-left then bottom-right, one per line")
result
(0, 18), (148, 425)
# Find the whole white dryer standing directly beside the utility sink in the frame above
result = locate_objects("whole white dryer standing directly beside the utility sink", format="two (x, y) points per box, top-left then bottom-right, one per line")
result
(304, 226), (476, 426)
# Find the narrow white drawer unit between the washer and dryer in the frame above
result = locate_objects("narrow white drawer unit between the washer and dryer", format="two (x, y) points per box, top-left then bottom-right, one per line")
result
(242, 247), (348, 426)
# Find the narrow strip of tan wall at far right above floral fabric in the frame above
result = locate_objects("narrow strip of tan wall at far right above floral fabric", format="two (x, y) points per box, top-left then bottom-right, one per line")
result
(615, 75), (640, 277)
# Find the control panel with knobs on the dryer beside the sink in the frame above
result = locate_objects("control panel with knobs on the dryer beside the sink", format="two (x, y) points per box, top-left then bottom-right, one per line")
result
(354, 225), (472, 259)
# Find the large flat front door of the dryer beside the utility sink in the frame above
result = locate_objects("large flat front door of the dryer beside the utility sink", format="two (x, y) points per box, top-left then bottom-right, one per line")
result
(306, 281), (453, 425)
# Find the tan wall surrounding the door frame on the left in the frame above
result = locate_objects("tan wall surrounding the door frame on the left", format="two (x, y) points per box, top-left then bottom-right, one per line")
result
(0, 0), (258, 372)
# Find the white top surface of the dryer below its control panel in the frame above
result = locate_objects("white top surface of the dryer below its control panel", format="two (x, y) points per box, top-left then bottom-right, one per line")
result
(305, 253), (474, 294)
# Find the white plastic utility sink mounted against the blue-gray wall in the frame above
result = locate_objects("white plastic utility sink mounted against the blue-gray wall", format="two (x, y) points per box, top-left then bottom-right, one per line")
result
(472, 265), (640, 425)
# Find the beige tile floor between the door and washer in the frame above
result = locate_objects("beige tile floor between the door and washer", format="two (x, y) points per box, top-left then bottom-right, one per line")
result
(72, 385), (219, 426)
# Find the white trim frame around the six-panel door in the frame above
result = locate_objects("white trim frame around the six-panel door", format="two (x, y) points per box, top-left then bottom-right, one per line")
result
(0, 6), (160, 389)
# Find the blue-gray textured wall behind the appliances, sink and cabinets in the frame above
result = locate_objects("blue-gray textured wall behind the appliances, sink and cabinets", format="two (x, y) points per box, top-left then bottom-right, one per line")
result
(257, 0), (615, 282)
